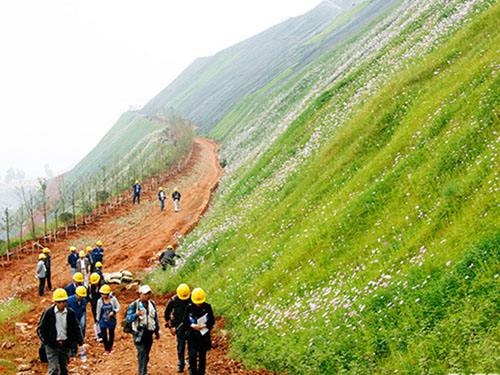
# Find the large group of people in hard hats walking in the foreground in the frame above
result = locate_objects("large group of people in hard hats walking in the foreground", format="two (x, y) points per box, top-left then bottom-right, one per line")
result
(37, 241), (215, 375)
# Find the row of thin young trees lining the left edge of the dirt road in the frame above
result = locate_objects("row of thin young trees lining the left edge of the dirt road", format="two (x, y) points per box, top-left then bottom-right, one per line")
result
(0, 115), (194, 261)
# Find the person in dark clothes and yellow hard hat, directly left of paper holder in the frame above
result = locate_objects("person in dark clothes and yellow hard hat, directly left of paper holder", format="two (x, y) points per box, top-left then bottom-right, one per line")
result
(165, 284), (191, 373)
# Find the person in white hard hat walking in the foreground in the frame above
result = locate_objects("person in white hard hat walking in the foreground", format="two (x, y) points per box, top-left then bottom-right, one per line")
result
(126, 285), (160, 375)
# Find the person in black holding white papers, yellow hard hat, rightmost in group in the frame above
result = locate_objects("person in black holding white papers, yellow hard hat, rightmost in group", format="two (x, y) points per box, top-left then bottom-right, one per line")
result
(184, 288), (215, 375)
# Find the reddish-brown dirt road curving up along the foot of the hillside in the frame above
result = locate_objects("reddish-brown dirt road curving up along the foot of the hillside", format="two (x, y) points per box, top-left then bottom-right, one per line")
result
(0, 138), (272, 375)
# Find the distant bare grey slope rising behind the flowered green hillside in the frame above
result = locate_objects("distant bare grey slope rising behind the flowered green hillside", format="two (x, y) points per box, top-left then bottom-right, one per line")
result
(143, 0), (397, 131)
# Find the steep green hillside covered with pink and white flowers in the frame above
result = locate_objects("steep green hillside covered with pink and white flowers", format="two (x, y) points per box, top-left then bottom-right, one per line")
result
(150, 0), (500, 374)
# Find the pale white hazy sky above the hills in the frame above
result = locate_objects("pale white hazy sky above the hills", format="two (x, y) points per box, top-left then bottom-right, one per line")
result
(0, 0), (320, 176)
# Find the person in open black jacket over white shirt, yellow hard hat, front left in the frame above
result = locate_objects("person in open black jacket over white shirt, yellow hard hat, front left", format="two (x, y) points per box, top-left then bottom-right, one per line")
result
(37, 288), (83, 375)
